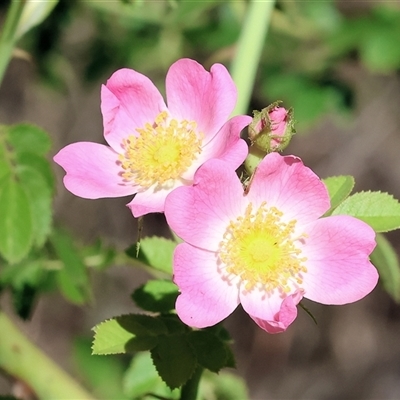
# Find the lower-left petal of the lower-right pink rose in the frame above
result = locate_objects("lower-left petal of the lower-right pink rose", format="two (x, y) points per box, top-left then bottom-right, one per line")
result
(174, 243), (239, 328)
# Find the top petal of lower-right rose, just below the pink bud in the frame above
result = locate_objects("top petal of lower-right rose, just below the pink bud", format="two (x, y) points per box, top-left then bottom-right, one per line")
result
(247, 153), (330, 225)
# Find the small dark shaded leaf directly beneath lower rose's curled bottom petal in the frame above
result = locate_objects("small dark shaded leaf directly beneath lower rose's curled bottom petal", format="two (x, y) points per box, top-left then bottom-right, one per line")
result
(187, 331), (228, 372)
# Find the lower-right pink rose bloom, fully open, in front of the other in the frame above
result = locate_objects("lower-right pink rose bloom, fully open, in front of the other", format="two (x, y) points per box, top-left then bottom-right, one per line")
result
(165, 153), (378, 333)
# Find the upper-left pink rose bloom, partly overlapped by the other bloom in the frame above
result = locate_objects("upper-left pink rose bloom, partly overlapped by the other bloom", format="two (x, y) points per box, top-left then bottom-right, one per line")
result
(54, 59), (251, 217)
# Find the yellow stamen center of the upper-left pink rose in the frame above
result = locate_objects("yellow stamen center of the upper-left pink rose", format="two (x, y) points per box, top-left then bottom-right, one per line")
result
(119, 111), (202, 189)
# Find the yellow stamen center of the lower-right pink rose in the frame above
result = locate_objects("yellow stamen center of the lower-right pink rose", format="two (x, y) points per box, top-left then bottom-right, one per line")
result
(219, 202), (307, 293)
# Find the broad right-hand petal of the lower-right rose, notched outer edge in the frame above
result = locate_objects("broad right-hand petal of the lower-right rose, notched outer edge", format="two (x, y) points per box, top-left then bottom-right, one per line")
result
(302, 215), (378, 304)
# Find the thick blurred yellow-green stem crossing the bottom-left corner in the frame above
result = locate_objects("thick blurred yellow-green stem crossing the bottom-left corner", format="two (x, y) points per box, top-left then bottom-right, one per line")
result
(0, 311), (94, 400)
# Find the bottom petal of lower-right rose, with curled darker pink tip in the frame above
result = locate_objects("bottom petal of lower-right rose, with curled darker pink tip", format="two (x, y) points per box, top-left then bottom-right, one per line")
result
(240, 290), (303, 333)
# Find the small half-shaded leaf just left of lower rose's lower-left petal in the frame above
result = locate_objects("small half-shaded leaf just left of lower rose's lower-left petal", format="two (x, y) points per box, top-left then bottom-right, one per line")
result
(132, 280), (178, 313)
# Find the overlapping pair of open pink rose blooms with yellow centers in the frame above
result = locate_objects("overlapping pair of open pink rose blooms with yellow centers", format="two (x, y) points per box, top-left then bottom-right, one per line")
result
(54, 59), (378, 333)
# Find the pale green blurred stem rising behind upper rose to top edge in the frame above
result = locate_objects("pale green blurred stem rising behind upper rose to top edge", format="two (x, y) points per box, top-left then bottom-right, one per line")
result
(231, 0), (275, 115)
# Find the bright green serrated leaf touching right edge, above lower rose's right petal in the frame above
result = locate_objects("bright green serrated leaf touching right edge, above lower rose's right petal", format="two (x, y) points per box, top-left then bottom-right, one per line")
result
(332, 191), (400, 232)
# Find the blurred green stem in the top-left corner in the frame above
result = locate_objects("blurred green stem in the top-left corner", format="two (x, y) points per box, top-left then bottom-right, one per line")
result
(0, 0), (26, 84)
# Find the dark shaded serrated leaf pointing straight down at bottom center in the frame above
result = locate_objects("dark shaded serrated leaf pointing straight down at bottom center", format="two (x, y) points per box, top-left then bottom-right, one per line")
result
(150, 334), (197, 389)
